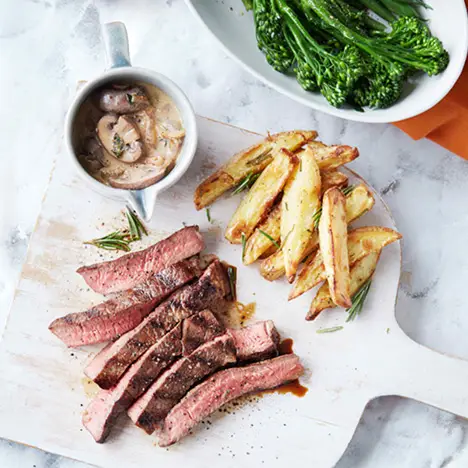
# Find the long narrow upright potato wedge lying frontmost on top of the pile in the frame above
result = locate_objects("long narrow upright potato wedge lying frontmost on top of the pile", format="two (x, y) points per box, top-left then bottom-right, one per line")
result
(318, 187), (351, 307)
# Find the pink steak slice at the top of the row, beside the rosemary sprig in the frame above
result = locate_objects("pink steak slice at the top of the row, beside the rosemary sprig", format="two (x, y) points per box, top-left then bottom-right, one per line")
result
(77, 226), (205, 294)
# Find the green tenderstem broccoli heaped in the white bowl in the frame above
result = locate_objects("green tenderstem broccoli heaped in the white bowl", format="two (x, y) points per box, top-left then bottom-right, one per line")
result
(252, 0), (449, 108)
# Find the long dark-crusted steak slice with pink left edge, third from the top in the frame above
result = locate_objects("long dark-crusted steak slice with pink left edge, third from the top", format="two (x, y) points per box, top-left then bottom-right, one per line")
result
(85, 260), (229, 389)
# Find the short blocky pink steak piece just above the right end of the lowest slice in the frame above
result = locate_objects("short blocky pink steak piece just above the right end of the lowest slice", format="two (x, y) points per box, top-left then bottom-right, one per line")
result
(228, 320), (280, 361)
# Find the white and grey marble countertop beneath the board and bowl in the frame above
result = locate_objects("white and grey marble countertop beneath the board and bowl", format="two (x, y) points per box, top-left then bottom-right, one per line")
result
(0, 0), (468, 468)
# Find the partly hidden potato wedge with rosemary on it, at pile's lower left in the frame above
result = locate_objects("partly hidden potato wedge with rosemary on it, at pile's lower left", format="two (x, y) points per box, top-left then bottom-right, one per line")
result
(243, 203), (281, 265)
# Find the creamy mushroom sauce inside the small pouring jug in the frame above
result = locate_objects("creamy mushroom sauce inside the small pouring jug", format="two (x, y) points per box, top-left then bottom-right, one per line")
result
(73, 83), (185, 190)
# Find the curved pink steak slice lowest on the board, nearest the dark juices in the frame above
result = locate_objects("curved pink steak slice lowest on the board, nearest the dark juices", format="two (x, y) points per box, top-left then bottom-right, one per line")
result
(159, 354), (304, 447)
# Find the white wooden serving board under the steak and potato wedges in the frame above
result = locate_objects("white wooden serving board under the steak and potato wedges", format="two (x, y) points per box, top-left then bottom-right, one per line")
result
(0, 118), (468, 468)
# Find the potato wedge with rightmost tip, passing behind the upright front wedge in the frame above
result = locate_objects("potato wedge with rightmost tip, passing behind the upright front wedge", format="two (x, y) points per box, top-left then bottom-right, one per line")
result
(288, 226), (401, 300)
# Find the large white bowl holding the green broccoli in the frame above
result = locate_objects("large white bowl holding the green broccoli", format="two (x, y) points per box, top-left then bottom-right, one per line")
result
(186, 0), (468, 122)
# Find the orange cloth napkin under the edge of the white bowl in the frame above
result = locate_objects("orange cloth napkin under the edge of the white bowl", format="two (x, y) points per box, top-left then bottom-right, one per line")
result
(394, 0), (468, 159)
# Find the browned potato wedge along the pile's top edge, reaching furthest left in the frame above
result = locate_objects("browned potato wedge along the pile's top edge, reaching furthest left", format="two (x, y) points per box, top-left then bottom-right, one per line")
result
(193, 130), (317, 210)
